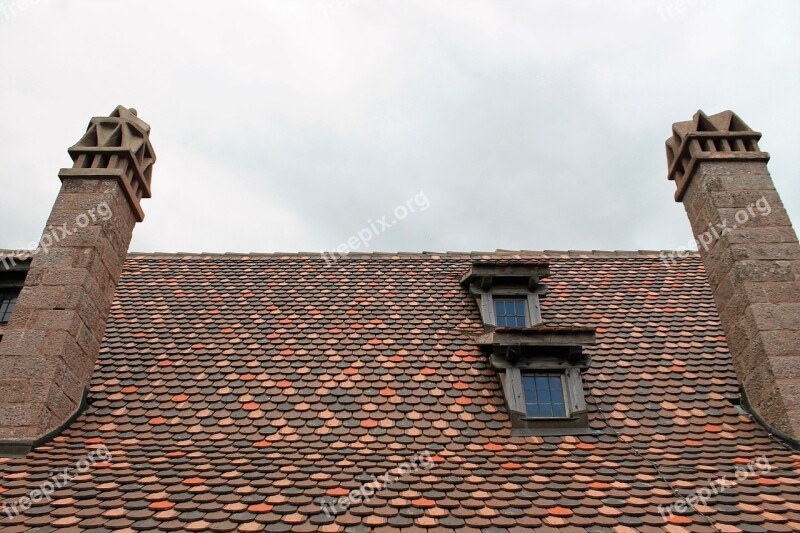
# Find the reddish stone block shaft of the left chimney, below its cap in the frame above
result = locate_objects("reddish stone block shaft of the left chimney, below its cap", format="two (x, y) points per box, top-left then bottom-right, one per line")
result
(0, 179), (139, 439)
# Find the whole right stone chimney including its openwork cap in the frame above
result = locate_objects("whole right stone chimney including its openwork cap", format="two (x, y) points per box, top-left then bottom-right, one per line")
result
(667, 111), (800, 439)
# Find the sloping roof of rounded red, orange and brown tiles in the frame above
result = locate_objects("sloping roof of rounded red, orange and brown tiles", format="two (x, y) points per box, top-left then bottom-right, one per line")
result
(0, 252), (800, 533)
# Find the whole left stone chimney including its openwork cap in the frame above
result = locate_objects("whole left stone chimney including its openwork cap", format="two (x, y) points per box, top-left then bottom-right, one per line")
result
(0, 106), (155, 455)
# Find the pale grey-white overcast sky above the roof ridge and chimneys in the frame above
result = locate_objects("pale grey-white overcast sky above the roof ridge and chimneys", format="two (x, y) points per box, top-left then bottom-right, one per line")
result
(0, 0), (800, 252)
